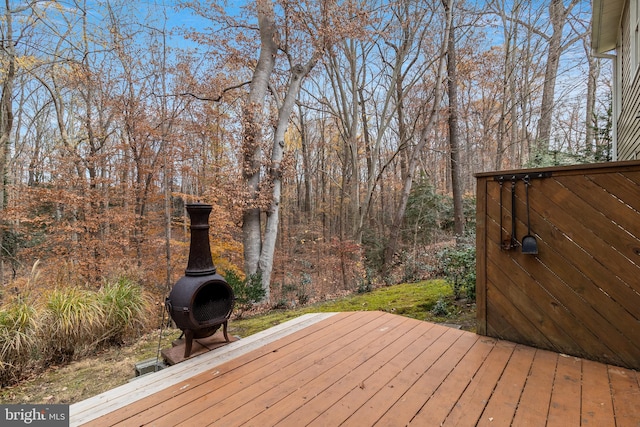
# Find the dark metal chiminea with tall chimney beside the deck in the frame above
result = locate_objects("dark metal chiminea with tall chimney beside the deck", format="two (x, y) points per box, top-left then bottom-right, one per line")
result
(166, 203), (235, 359)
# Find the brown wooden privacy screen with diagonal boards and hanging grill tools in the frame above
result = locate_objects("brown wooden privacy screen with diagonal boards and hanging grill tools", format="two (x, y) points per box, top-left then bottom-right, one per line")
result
(476, 161), (640, 369)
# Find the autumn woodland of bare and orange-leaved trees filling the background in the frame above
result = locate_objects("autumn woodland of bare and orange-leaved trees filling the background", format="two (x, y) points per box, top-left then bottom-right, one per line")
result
(0, 0), (611, 303)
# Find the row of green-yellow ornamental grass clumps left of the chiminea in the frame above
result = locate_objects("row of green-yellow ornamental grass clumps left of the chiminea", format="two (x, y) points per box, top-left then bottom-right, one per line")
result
(0, 279), (150, 385)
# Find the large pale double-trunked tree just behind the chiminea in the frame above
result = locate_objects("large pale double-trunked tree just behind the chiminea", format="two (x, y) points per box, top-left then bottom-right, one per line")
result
(242, 0), (358, 300)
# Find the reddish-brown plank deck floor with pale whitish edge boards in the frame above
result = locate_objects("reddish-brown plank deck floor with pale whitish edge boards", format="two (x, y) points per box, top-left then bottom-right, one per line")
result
(70, 312), (640, 427)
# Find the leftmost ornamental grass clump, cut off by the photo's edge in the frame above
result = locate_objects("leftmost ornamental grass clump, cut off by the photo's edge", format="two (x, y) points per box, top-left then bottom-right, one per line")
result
(0, 298), (37, 385)
